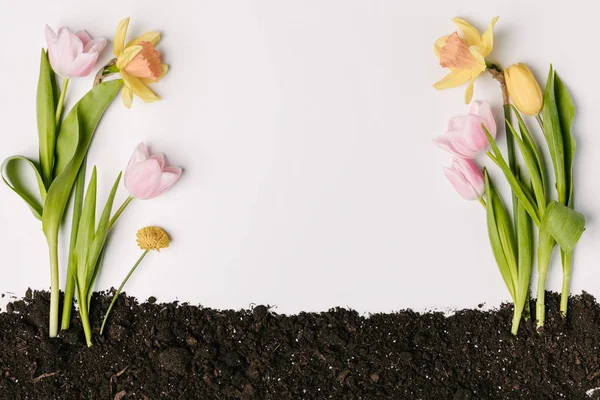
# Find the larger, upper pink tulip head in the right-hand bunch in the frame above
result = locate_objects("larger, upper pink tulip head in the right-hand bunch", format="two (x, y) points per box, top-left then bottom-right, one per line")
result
(433, 101), (496, 159)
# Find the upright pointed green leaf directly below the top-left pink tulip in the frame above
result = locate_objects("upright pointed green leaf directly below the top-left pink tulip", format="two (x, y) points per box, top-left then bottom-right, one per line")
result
(37, 49), (57, 187)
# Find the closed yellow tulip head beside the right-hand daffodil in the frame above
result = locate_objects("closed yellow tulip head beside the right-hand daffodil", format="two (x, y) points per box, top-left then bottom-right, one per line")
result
(504, 63), (544, 116)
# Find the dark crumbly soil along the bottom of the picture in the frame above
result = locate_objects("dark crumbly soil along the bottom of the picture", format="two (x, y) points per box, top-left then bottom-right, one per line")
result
(0, 292), (600, 400)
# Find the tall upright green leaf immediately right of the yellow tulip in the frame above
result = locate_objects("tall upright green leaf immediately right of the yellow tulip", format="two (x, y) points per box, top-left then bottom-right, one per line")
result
(542, 65), (567, 204)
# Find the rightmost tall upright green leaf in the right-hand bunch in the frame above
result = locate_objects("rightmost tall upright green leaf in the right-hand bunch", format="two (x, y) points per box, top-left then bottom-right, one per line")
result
(554, 73), (577, 208)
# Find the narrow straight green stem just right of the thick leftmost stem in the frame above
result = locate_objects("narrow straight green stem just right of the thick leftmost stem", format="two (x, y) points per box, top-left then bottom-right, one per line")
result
(60, 160), (85, 330)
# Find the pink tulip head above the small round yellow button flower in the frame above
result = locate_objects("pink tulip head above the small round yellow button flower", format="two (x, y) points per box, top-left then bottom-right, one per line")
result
(125, 143), (182, 199)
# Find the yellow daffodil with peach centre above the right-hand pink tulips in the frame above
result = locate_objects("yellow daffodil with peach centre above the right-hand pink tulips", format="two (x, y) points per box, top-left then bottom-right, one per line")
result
(433, 17), (498, 103)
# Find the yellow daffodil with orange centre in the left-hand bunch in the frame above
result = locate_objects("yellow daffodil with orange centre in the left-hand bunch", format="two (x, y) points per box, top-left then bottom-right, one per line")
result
(114, 18), (169, 108)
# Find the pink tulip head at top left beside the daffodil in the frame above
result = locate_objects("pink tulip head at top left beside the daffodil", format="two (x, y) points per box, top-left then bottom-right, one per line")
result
(46, 25), (106, 78)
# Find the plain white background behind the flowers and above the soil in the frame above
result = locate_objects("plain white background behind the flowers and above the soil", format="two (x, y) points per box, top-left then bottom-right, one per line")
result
(0, 0), (600, 313)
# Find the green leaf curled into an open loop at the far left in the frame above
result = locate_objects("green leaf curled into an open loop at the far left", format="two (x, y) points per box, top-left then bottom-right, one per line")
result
(0, 156), (46, 220)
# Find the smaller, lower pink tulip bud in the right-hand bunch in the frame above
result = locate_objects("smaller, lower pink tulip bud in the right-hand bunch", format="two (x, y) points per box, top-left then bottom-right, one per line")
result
(444, 157), (485, 200)
